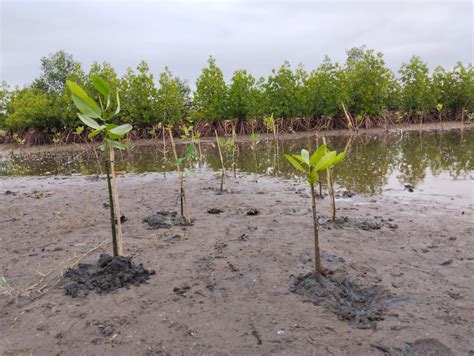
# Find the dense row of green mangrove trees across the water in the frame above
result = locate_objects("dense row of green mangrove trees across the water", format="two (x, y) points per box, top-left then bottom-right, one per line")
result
(0, 46), (474, 133)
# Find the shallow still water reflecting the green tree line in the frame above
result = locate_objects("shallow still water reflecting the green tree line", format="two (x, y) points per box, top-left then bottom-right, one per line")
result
(0, 130), (474, 194)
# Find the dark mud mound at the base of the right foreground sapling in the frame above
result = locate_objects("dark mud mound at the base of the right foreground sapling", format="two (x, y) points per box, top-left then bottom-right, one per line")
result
(291, 273), (406, 329)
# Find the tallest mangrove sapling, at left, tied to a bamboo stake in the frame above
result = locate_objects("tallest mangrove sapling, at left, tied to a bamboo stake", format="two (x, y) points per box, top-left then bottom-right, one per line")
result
(66, 76), (132, 256)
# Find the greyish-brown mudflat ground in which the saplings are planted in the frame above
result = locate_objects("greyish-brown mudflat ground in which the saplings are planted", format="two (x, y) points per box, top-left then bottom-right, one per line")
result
(0, 171), (474, 355)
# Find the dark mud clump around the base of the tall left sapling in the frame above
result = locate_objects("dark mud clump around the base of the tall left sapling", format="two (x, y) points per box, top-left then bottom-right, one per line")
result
(64, 254), (155, 298)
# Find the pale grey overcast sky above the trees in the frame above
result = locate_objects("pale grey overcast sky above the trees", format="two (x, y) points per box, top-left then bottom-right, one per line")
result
(0, 0), (474, 85)
